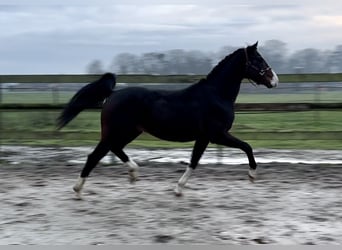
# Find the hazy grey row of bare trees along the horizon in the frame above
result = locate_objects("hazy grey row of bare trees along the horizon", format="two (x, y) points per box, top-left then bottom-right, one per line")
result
(86, 40), (342, 75)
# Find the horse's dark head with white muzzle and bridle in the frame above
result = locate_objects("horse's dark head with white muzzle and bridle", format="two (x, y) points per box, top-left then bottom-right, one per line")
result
(245, 42), (279, 88)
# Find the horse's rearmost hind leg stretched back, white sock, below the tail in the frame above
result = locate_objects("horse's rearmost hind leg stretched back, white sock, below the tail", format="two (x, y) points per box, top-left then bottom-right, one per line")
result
(73, 140), (110, 194)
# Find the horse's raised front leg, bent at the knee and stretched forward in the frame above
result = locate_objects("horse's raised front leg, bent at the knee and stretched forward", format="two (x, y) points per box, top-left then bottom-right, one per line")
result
(210, 132), (257, 182)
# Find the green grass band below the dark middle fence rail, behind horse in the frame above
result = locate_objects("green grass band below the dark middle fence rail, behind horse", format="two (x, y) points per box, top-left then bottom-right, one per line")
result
(0, 111), (342, 149)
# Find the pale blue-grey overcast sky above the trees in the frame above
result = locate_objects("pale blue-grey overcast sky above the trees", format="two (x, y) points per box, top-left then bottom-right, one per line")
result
(0, 0), (342, 74)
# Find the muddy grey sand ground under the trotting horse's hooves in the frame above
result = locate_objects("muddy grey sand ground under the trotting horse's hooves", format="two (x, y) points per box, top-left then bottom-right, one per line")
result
(0, 147), (342, 245)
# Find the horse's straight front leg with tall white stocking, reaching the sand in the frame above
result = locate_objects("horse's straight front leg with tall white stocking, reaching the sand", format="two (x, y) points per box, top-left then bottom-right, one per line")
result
(175, 139), (209, 196)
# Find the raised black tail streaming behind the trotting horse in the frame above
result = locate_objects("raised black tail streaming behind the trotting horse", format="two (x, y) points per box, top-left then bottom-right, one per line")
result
(57, 73), (116, 129)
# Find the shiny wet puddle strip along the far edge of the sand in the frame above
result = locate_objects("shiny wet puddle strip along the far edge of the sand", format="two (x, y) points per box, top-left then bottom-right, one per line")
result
(1, 146), (342, 165)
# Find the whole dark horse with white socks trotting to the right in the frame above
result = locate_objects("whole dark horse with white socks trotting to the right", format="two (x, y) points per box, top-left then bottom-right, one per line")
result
(58, 43), (278, 195)
